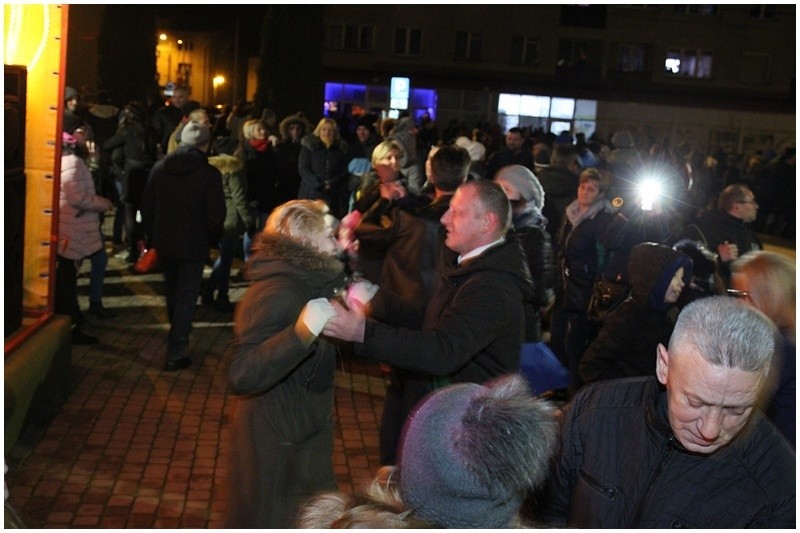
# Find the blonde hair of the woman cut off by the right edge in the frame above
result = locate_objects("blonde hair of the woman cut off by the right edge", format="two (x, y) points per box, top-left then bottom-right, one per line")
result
(731, 250), (797, 335)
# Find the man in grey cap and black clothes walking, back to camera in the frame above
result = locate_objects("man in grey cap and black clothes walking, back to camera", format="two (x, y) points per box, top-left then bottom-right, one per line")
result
(142, 122), (226, 371)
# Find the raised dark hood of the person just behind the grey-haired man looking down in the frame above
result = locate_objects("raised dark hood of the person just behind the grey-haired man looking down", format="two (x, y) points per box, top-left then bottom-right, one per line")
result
(628, 242), (692, 311)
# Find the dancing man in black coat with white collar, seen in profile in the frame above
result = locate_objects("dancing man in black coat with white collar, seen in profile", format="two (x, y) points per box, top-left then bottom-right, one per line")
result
(324, 180), (533, 454)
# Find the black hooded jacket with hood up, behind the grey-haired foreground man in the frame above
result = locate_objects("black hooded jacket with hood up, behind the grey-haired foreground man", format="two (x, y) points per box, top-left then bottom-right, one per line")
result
(580, 243), (692, 383)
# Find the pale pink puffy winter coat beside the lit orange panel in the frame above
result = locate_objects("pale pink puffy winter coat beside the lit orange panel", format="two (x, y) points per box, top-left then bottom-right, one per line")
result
(58, 154), (114, 259)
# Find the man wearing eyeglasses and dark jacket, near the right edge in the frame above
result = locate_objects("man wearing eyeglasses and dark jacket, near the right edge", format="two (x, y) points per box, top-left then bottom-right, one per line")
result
(678, 183), (764, 287)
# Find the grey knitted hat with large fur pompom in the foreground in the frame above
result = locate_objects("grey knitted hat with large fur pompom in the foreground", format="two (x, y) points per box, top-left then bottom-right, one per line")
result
(399, 374), (555, 528)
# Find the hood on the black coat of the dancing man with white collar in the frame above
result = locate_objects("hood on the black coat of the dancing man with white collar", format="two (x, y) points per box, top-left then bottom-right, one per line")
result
(444, 236), (534, 301)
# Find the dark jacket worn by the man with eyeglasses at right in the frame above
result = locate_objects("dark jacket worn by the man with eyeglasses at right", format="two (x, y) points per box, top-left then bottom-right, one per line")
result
(680, 211), (764, 287)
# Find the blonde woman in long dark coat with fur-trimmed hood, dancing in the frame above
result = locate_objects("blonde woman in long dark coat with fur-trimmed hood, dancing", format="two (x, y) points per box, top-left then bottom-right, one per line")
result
(226, 200), (347, 528)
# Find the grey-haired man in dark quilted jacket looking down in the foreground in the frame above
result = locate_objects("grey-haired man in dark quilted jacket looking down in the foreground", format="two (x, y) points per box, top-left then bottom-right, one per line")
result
(537, 296), (797, 530)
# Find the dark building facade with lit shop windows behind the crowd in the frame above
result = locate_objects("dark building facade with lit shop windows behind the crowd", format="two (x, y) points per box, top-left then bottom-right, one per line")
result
(324, 4), (796, 150)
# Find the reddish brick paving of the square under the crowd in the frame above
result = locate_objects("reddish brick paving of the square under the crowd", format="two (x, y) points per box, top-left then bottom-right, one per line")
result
(5, 242), (386, 528)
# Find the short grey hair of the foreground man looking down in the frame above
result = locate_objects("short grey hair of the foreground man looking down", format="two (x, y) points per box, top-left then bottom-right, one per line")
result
(669, 296), (776, 376)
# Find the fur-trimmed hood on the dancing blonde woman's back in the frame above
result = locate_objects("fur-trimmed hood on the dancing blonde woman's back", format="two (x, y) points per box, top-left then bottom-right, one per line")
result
(244, 233), (346, 286)
